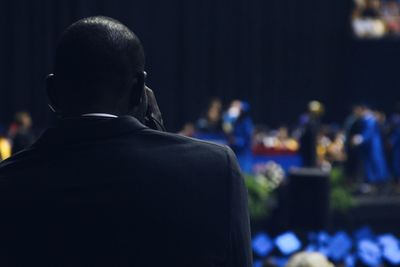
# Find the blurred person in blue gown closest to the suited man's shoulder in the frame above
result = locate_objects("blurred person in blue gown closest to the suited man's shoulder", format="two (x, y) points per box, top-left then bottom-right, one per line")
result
(223, 100), (253, 173)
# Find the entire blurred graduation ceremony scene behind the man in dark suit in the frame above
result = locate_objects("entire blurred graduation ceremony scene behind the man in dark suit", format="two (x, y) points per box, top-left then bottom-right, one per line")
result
(0, 0), (400, 267)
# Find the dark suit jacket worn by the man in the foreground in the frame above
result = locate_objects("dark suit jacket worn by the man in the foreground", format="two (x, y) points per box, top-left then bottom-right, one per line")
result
(0, 116), (251, 267)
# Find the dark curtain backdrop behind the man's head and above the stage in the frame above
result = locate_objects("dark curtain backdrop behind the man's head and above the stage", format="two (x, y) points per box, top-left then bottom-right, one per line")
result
(0, 0), (400, 130)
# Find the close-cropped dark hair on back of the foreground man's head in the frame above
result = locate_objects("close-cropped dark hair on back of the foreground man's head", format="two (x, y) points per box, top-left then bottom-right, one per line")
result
(54, 16), (144, 105)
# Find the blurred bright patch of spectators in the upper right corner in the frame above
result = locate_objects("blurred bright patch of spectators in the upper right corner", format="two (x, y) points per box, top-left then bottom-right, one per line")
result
(352, 0), (400, 38)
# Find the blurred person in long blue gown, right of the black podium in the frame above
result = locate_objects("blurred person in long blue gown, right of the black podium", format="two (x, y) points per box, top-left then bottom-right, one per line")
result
(352, 105), (390, 184)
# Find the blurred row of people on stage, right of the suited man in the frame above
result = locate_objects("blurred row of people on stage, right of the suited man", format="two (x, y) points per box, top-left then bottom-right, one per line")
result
(180, 99), (400, 188)
